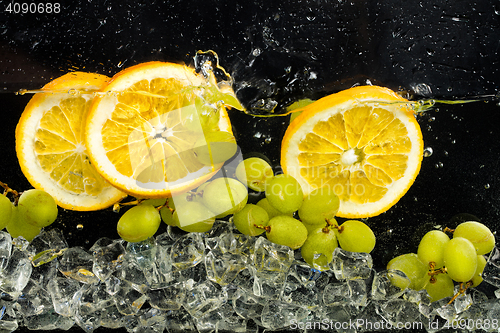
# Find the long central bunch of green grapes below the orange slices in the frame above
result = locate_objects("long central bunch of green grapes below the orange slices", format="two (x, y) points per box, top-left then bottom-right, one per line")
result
(117, 157), (375, 270)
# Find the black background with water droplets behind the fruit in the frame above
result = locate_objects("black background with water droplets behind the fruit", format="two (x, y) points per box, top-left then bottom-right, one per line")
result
(0, 0), (500, 332)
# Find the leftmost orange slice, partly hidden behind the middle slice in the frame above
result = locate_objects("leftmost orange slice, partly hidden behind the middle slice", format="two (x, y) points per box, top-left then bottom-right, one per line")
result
(16, 72), (125, 211)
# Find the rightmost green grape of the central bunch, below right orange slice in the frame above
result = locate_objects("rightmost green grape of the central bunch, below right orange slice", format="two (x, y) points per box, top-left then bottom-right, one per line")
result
(335, 220), (375, 253)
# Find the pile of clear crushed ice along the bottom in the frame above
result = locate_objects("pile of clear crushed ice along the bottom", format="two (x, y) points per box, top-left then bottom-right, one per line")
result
(0, 221), (500, 332)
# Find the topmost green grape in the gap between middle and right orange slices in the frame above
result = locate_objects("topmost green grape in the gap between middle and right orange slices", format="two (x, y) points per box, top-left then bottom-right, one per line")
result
(235, 157), (274, 192)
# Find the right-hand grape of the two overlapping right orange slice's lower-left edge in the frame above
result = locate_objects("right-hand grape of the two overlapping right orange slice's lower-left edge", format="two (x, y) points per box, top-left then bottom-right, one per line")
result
(299, 186), (340, 226)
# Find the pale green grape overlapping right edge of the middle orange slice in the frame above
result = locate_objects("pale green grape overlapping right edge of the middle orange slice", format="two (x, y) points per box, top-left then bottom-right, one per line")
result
(194, 131), (238, 165)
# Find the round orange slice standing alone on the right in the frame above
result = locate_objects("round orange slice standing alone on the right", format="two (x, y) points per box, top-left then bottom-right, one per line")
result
(281, 86), (423, 218)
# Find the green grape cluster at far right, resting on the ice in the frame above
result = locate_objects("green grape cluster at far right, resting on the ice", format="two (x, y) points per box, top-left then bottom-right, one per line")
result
(387, 221), (495, 302)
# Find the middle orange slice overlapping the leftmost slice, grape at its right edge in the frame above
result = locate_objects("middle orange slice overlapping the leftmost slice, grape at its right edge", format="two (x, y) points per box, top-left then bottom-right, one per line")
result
(85, 62), (239, 198)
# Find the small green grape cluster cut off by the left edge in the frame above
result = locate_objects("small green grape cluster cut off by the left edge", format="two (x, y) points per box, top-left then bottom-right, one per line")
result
(0, 186), (58, 241)
